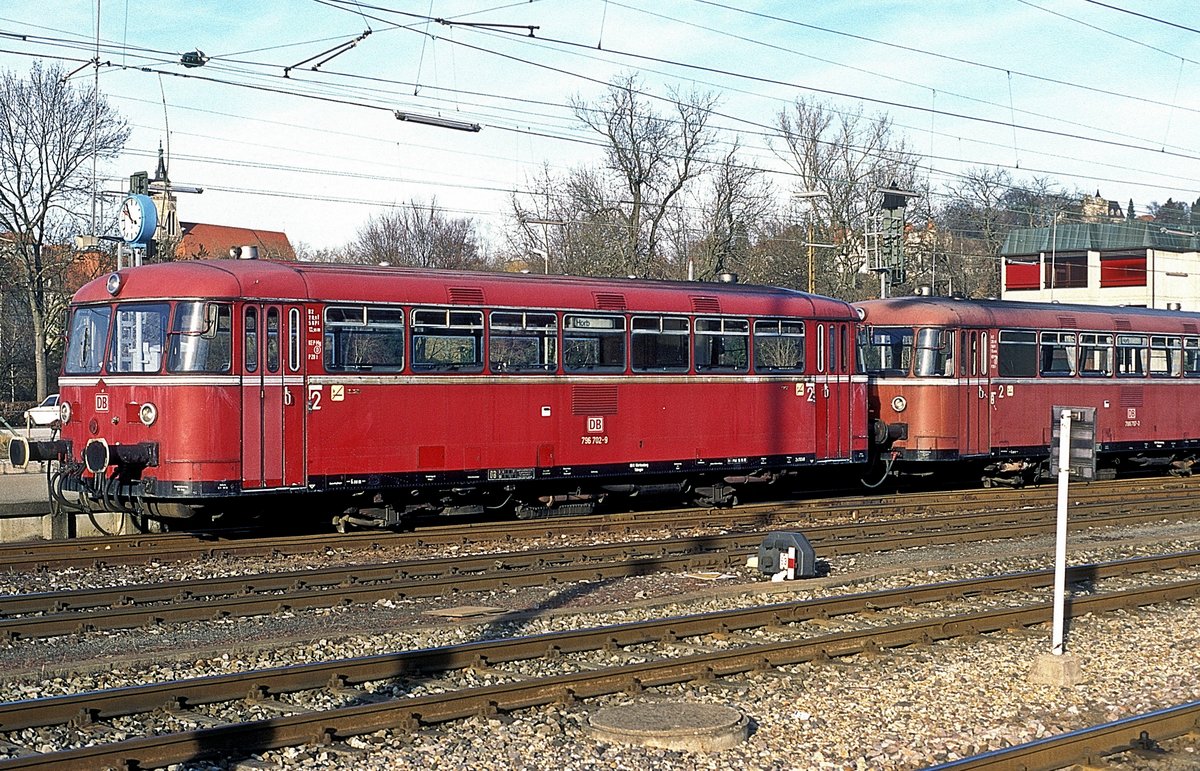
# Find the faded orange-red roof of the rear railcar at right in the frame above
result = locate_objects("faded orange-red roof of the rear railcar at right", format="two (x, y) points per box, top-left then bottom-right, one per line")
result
(854, 297), (1200, 333)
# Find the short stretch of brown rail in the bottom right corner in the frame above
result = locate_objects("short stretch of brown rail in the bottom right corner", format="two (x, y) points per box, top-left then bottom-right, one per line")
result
(926, 701), (1200, 771)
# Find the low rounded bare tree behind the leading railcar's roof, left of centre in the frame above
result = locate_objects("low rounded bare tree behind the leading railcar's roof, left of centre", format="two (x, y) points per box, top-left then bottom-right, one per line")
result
(342, 199), (490, 270)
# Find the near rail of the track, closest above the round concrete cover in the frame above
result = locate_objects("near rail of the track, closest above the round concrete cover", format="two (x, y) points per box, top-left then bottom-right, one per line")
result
(0, 580), (1200, 771)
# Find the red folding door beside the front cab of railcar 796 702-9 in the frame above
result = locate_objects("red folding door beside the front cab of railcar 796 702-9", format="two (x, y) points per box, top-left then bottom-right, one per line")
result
(241, 304), (305, 490)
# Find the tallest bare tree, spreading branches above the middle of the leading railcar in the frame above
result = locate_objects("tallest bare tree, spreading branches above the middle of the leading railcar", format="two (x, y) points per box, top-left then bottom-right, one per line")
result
(571, 74), (716, 275)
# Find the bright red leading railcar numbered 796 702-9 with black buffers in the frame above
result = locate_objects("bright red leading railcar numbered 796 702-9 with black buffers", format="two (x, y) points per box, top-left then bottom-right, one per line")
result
(14, 261), (868, 522)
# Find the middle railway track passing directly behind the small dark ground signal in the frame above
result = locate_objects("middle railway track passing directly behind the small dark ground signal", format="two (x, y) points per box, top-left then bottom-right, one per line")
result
(0, 501), (1200, 640)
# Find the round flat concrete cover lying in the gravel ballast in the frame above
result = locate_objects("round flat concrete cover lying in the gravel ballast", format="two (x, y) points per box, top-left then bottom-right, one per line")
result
(588, 701), (750, 752)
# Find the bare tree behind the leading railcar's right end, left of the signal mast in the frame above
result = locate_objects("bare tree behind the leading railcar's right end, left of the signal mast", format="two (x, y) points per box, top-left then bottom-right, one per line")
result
(775, 98), (919, 298)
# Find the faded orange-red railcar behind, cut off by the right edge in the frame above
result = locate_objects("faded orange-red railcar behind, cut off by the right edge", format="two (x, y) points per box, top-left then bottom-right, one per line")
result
(858, 297), (1200, 484)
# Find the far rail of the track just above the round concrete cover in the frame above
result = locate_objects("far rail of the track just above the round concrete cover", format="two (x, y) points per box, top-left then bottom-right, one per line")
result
(0, 551), (1200, 731)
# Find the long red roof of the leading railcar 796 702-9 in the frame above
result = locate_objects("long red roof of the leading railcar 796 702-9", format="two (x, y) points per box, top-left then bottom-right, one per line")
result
(74, 259), (856, 318)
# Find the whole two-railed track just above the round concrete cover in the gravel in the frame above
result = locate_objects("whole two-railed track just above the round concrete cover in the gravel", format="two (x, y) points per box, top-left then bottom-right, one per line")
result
(0, 552), (1200, 769)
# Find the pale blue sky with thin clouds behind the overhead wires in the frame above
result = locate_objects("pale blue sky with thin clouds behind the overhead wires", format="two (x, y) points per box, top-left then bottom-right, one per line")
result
(0, 0), (1200, 247)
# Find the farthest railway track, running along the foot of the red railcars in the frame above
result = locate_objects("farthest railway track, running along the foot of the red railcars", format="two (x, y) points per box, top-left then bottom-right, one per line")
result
(0, 478), (1200, 572)
